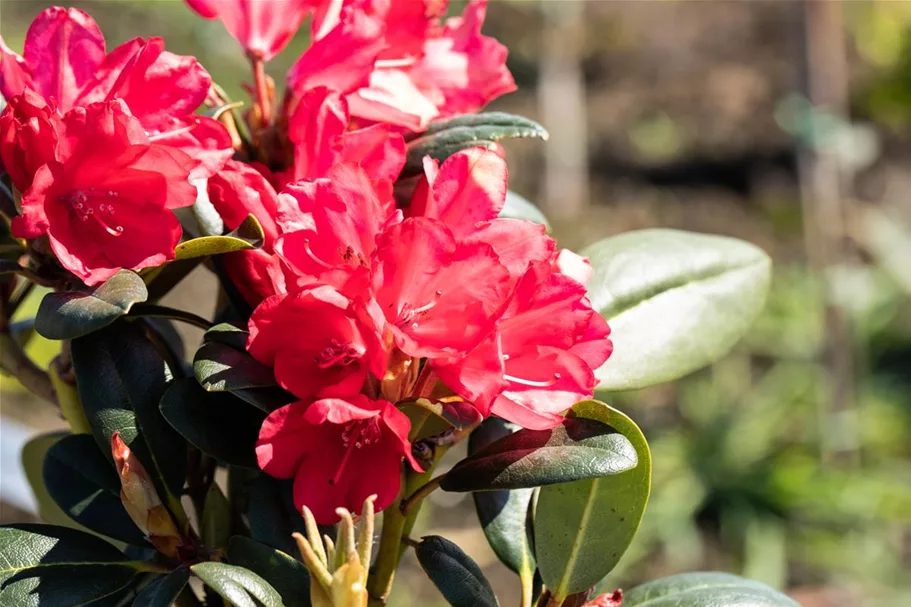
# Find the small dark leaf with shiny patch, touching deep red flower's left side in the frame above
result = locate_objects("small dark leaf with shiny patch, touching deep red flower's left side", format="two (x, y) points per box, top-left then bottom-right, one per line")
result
(193, 341), (275, 392)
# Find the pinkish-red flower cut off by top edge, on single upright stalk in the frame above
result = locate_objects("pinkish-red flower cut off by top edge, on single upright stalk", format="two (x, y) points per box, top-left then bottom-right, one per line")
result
(187, 0), (320, 61)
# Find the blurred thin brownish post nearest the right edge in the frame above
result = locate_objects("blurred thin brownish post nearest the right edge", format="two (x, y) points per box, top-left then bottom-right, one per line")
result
(796, 0), (859, 464)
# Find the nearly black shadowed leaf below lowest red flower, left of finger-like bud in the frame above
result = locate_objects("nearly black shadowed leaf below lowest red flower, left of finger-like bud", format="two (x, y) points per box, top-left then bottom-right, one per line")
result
(247, 474), (306, 554)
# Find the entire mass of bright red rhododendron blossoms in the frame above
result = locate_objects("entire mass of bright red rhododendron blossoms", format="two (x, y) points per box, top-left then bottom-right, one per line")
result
(0, 0), (611, 523)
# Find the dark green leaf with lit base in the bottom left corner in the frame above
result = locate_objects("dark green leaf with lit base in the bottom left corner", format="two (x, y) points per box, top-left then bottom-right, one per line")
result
(0, 524), (141, 607)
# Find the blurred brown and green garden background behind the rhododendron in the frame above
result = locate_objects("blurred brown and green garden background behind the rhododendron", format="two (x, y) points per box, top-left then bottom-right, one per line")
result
(0, 0), (911, 607)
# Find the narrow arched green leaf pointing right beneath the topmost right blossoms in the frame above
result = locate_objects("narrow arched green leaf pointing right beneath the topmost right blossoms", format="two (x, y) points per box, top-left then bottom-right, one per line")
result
(402, 112), (548, 177)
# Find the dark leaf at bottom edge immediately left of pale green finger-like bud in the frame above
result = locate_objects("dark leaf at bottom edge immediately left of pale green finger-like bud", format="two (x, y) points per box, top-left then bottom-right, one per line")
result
(228, 536), (310, 607)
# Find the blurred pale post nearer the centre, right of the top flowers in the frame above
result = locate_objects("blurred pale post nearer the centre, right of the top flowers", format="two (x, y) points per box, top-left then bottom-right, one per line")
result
(538, 0), (589, 219)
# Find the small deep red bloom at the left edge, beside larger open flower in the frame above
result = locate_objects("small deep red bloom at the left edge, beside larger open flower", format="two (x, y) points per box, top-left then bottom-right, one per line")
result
(0, 89), (63, 192)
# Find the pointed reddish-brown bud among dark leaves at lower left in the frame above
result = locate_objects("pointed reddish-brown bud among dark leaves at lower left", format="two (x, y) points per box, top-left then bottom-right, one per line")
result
(111, 432), (184, 558)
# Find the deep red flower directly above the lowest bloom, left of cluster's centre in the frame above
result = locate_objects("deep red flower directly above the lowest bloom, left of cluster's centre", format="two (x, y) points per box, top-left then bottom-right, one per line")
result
(247, 285), (386, 399)
